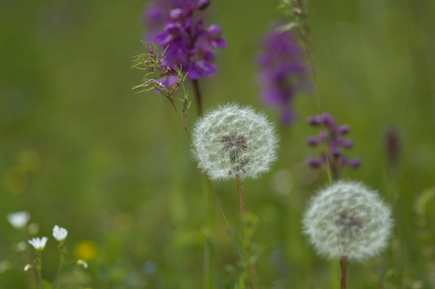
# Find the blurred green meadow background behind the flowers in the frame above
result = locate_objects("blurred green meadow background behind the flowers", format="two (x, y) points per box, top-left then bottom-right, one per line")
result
(0, 0), (435, 289)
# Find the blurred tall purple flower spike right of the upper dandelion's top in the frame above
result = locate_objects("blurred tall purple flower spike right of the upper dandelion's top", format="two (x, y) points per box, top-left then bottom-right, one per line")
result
(257, 25), (311, 124)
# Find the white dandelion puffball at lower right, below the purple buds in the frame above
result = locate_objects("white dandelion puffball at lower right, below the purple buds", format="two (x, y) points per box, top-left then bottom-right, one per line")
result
(303, 181), (393, 261)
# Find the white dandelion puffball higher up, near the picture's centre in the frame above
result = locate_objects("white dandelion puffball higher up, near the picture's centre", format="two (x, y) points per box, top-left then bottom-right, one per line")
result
(193, 104), (278, 180)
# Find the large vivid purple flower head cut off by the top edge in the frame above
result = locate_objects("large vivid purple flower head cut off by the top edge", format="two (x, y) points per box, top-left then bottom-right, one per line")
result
(146, 0), (227, 79)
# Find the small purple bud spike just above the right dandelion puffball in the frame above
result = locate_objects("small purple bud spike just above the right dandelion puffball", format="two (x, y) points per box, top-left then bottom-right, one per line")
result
(306, 113), (361, 180)
